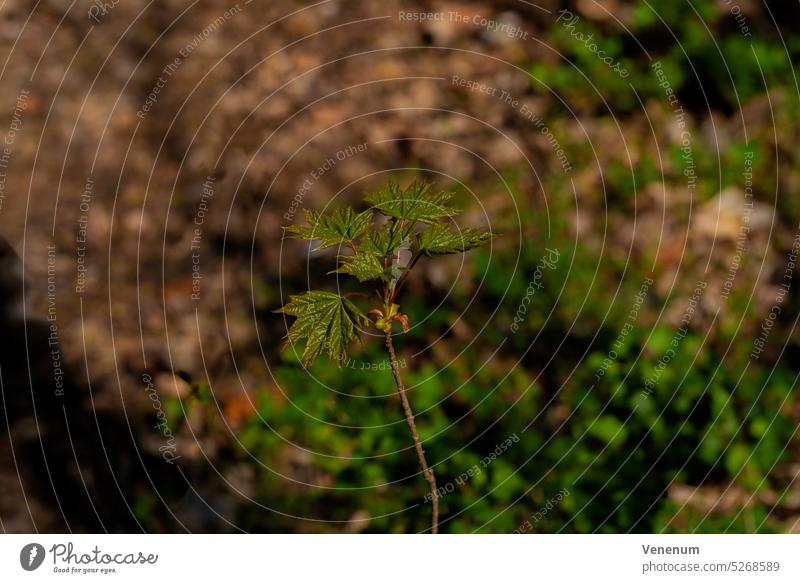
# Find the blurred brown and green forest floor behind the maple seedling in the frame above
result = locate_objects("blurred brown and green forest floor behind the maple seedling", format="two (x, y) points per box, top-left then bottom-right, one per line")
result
(0, 0), (800, 533)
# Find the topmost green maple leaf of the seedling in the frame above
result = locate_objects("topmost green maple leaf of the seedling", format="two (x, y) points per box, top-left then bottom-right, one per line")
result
(364, 182), (458, 223)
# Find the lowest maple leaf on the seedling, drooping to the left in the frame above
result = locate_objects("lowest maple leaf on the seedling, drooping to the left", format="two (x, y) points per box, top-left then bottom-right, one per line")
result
(276, 290), (369, 366)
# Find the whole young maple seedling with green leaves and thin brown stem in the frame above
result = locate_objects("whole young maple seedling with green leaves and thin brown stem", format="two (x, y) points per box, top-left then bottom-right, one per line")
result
(277, 182), (493, 534)
